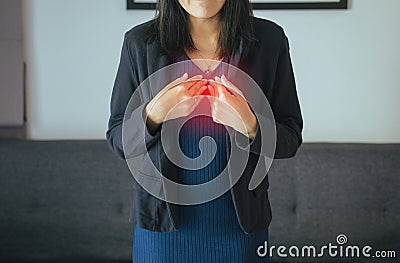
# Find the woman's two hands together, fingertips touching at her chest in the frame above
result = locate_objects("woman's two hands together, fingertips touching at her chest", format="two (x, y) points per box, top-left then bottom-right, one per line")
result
(146, 73), (257, 139)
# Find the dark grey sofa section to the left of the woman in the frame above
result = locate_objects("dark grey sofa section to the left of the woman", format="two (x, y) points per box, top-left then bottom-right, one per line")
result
(0, 140), (133, 262)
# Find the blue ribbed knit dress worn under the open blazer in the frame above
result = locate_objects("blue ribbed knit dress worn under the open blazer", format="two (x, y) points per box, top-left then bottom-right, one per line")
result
(132, 56), (269, 263)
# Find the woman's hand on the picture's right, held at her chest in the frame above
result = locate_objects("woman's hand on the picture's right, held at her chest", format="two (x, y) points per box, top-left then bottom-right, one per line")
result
(208, 75), (257, 140)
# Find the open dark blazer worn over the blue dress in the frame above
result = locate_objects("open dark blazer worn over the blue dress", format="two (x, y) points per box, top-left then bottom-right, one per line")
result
(106, 18), (303, 234)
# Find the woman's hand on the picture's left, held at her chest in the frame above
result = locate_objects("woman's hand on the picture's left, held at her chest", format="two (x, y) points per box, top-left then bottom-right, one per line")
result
(145, 73), (208, 133)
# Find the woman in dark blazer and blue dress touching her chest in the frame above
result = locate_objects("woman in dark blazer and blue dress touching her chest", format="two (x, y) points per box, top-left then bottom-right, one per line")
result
(107, 0), (303, 263)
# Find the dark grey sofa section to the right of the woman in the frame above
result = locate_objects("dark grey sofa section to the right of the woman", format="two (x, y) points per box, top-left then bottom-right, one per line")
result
(269, 143), (400, 262)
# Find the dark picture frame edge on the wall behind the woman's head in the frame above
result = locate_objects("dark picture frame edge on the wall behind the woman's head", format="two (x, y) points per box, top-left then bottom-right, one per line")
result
(127, 0), (348, 9)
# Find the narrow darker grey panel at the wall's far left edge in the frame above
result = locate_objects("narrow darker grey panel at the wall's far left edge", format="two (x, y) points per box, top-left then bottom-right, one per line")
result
(0, 0), (23, 127)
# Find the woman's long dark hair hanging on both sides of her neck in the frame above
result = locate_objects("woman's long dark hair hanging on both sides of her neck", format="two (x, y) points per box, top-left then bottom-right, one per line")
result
(154, 0), (254, 56)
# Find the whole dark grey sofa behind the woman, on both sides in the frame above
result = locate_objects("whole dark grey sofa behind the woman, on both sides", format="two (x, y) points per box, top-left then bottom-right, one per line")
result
(0, 140), (400, 262)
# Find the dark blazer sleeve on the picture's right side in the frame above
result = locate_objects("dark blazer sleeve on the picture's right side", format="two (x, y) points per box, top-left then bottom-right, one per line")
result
(235, 29), (303, 159)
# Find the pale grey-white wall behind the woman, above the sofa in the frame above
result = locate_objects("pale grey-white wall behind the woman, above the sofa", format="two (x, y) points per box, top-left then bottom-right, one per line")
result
(23, 0), (400, 142)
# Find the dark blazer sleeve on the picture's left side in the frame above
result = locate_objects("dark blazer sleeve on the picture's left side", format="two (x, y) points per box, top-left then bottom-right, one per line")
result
(106, 33), (161, 159)
